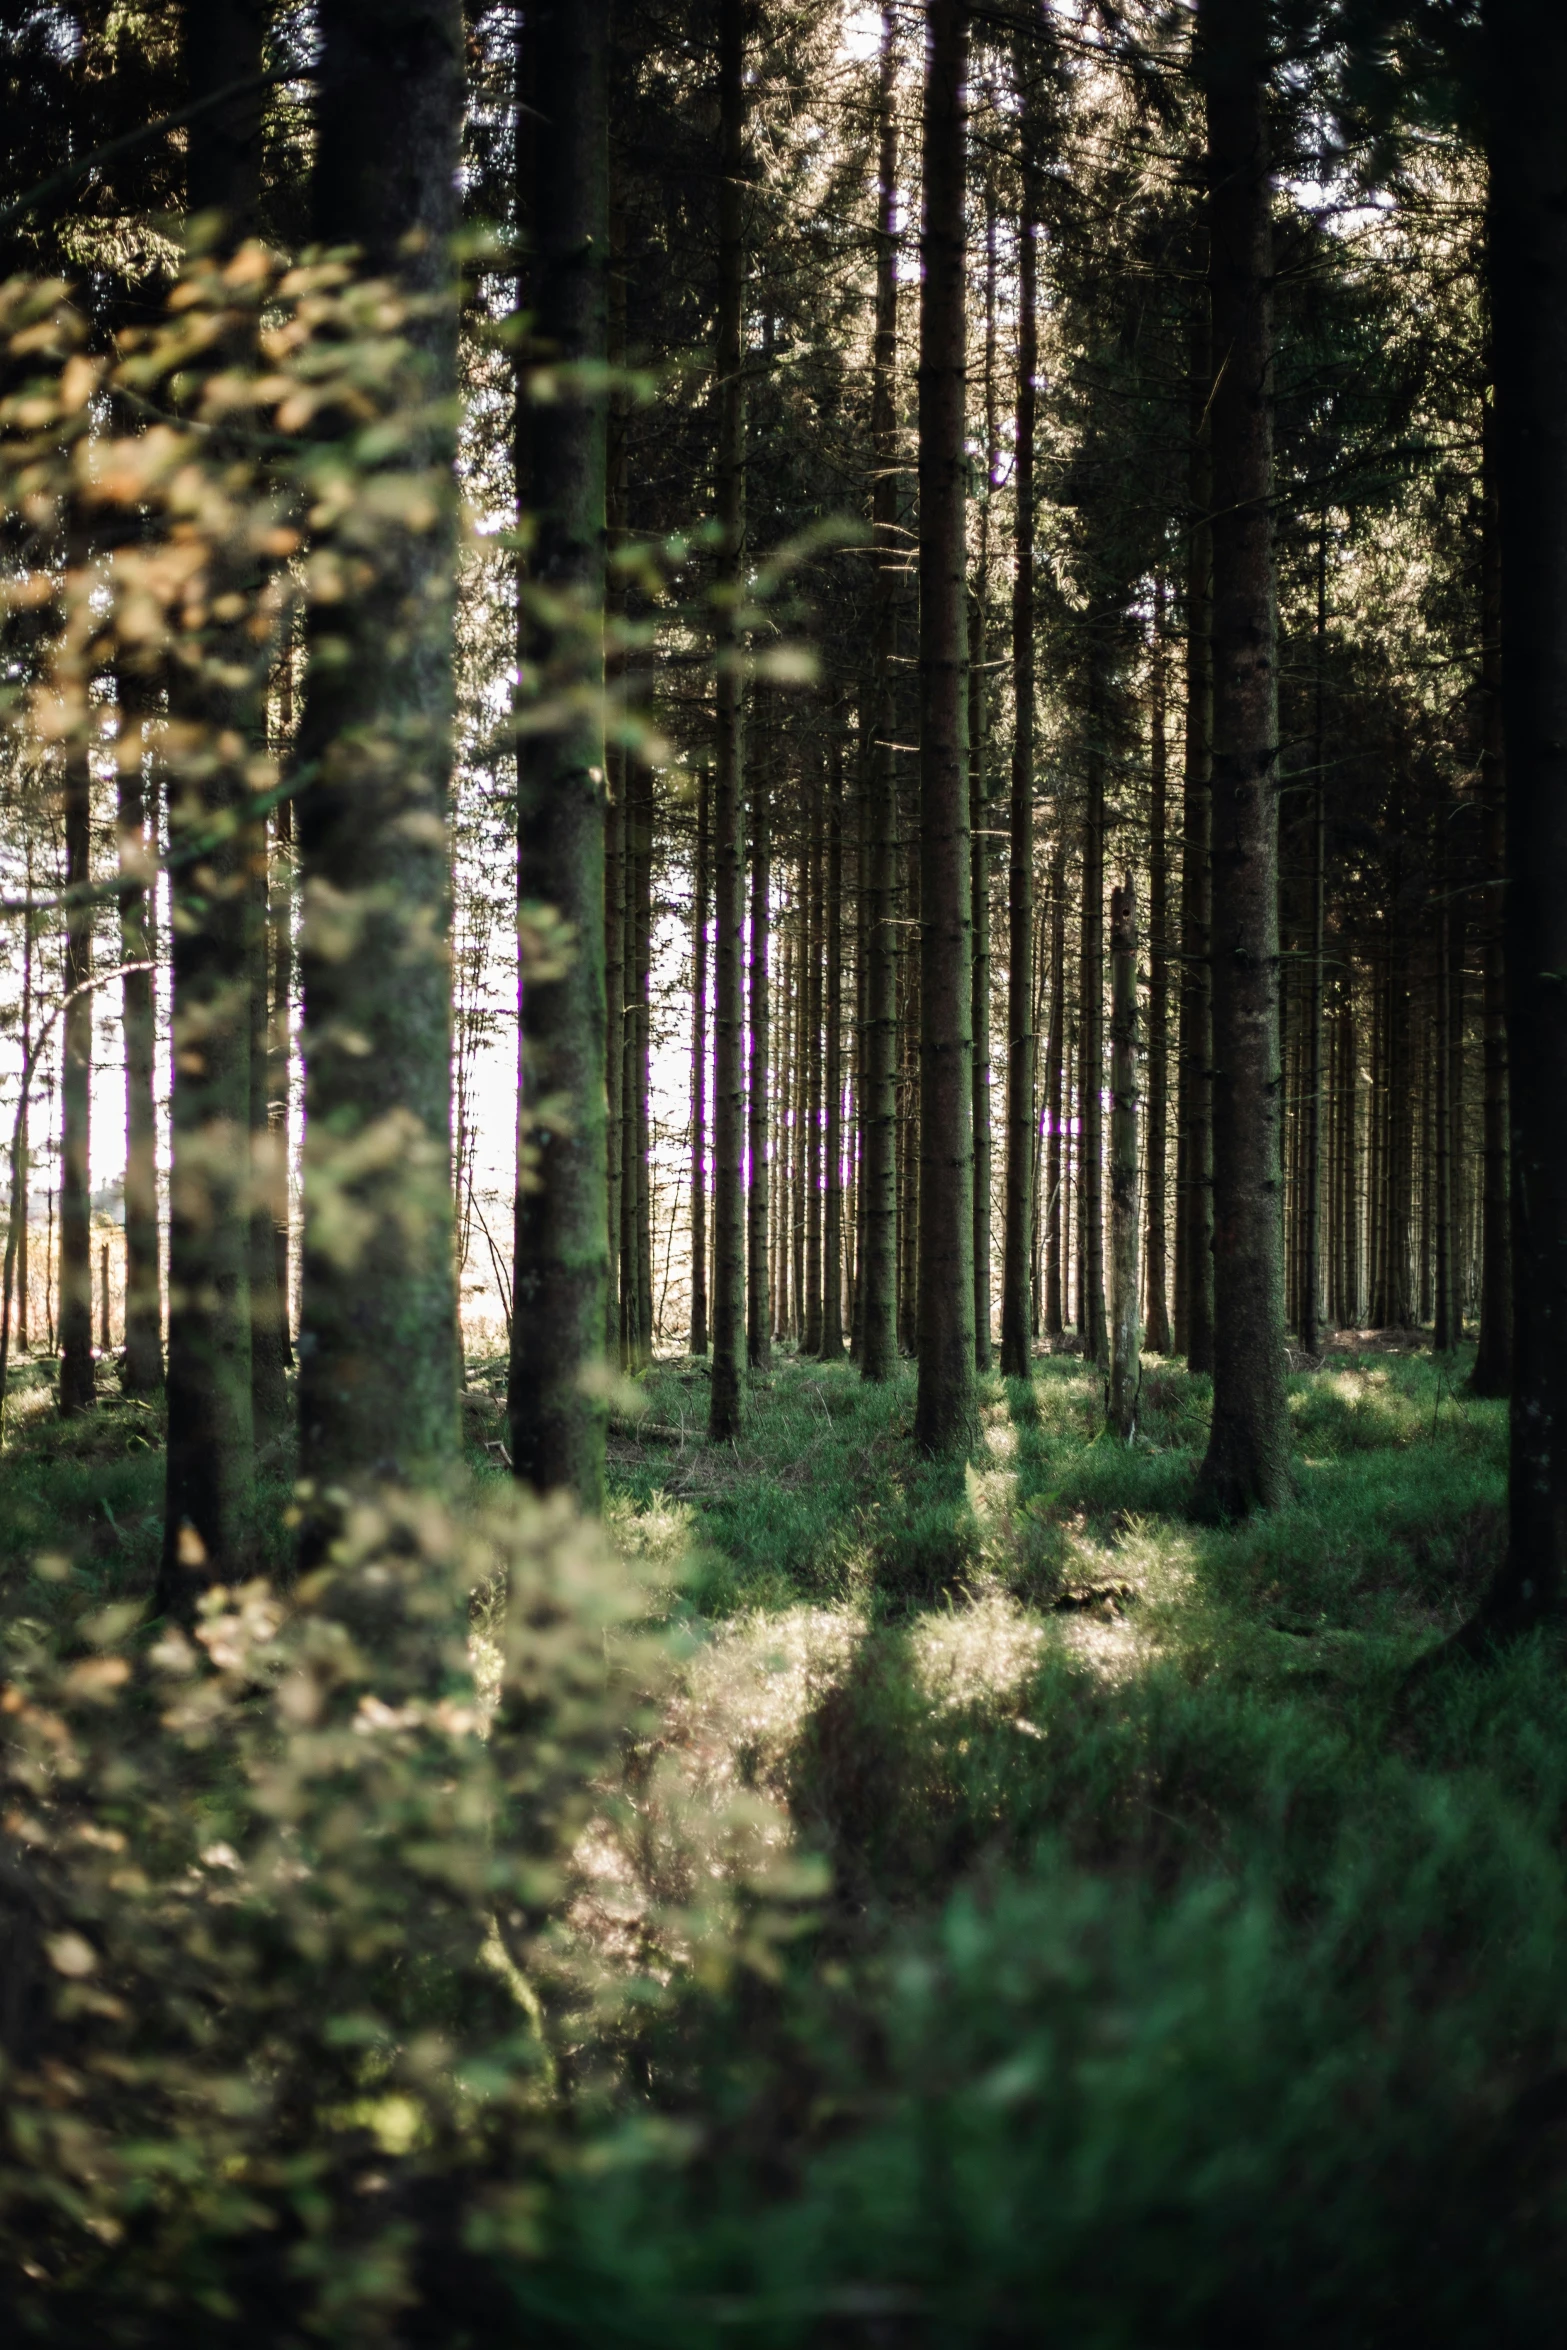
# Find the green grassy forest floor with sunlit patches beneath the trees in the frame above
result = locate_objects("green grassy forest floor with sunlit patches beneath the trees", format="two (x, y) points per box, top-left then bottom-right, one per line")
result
(0, 1342), (1567, 2350)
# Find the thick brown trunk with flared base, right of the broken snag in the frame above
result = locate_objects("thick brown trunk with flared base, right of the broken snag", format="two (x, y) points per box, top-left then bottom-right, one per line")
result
(1198, 0), (1290, 1516)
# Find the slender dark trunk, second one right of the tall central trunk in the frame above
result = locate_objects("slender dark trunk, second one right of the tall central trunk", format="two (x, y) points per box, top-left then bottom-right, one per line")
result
(1001, 202), (1038, 1379)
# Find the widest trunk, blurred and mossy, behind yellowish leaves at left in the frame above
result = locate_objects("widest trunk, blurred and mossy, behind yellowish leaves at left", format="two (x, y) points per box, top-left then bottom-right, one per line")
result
(298, 0), (463, 1522)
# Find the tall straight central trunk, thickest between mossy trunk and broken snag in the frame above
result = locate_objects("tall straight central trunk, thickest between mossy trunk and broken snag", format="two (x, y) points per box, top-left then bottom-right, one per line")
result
(914, 0), (977, 1452)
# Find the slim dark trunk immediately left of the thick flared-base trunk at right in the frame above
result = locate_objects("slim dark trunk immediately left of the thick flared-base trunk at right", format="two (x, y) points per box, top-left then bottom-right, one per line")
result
(1175, 270), (1212, 1372)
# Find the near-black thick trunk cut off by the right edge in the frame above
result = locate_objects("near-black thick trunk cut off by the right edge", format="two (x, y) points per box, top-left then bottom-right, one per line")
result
(1485, 0), (1567, 1631)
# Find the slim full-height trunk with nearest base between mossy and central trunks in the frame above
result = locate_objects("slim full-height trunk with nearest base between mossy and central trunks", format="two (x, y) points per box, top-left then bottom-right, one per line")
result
(707, 0), (745, 1443)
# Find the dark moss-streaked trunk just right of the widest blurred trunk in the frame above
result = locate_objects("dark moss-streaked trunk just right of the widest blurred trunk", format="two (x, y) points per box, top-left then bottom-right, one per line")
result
(507, 0), (608, 1511)
